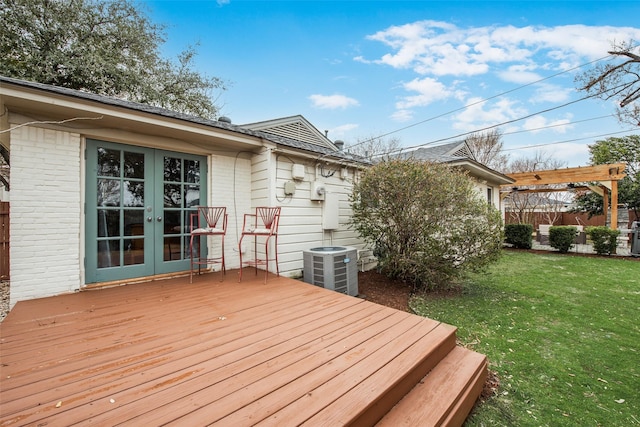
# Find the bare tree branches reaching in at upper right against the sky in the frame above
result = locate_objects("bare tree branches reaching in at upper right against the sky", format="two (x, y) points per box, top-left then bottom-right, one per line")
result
(576, 41), (640, 126)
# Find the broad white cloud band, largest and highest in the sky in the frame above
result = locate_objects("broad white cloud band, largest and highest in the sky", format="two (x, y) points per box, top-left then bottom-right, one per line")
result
(357, 21), (640, 76)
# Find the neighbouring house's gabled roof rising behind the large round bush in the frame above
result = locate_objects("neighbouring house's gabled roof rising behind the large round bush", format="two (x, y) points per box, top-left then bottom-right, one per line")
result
(394, 141), (515, 185)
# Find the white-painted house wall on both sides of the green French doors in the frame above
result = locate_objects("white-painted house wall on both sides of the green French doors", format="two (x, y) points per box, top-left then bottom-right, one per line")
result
(6, 122), (369, 304)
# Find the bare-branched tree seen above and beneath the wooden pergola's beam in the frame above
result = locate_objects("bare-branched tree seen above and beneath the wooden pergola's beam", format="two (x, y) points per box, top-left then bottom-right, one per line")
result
(505, 151), (566, 224)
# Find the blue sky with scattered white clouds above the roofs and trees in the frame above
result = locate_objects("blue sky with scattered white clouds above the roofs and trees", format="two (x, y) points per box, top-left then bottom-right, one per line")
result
(143, 0), (640, 167)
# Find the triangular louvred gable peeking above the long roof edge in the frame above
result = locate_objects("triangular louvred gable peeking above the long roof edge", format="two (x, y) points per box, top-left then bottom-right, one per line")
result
(241, 115), (338, 150)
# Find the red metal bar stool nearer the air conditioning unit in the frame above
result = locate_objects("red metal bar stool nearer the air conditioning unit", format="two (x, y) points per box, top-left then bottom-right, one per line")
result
(238, 207), (281, 283)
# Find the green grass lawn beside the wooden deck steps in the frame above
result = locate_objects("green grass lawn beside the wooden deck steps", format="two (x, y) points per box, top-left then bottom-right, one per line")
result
(411, 251), (640, 426)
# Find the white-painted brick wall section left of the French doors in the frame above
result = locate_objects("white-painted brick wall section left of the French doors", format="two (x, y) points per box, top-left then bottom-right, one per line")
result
(10, 127), (82, 306)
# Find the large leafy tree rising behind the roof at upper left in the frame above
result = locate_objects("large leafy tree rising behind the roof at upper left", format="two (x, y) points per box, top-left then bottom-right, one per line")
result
(0, 0), (224, 118)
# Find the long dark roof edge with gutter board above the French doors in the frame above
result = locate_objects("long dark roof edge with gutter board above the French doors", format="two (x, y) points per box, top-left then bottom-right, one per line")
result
(0, 76), (367, 163)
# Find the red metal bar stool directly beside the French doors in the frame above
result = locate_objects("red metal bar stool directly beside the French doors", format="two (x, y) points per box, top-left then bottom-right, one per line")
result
(189, 206), (227, 283)
